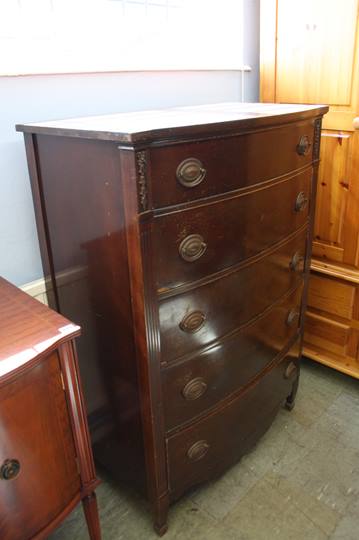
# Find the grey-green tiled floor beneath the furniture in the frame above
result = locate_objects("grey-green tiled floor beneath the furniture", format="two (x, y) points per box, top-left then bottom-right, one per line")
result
(50, 360), (359, 540)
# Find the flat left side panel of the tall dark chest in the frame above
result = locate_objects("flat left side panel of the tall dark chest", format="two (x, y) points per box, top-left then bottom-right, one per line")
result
(33, 136), (144, 484)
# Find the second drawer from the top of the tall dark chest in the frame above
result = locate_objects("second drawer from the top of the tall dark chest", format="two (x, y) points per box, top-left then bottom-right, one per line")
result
(152, 169), (312, 291)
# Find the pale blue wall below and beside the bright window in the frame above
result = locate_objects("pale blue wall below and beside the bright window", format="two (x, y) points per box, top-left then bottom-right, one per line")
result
(0, 0), (259, 285)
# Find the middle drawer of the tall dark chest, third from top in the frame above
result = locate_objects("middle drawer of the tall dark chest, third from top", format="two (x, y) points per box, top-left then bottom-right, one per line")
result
(159, 229), (307, 362)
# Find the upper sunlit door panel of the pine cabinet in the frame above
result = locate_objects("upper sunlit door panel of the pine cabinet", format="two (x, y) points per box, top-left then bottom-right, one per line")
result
(276, 0), (358, 105)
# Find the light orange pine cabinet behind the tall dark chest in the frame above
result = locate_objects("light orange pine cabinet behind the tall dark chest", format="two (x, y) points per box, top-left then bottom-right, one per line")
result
(260, 0), (359, 378)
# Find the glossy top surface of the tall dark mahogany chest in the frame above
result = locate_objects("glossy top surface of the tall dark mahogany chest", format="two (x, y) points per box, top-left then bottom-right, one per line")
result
(17, 102), (328, 144)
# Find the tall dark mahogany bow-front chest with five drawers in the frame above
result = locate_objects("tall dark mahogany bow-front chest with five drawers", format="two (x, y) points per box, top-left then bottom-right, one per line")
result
(18, 103), (327, 534)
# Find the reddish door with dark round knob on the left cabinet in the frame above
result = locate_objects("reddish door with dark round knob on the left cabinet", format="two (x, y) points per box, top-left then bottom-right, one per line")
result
(0, 352), (81, 540)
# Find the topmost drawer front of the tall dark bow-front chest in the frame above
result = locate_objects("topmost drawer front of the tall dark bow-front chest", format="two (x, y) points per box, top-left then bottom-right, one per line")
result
(150, 121), (314, 208)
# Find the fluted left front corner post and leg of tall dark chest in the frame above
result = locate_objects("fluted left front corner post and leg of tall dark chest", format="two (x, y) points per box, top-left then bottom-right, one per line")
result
(120, 149), (169, 535)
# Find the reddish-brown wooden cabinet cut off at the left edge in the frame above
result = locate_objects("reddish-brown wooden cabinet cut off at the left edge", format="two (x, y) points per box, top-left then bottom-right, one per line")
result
(0, 278), (101, 540)
